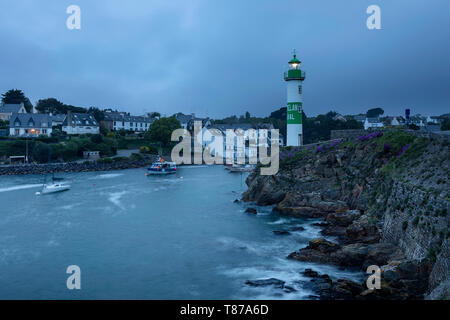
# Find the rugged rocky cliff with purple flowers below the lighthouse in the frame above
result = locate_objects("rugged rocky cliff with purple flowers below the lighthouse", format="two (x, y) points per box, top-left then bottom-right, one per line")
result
(243, 131), (450, 299)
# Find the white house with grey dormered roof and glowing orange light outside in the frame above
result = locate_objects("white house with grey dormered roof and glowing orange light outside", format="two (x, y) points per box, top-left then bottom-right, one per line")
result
(9, 113), (52, 137)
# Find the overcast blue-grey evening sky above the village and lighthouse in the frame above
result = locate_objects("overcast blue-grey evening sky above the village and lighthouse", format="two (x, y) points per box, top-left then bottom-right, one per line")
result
(0, 0), (450, 118)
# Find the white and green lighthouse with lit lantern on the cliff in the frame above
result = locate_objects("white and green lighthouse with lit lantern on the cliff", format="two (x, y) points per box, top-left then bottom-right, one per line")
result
(284, 50), (305, 147)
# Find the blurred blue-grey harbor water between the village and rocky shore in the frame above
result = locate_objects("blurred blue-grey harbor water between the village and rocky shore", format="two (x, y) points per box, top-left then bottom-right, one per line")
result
(0, 166), (361, 299)
